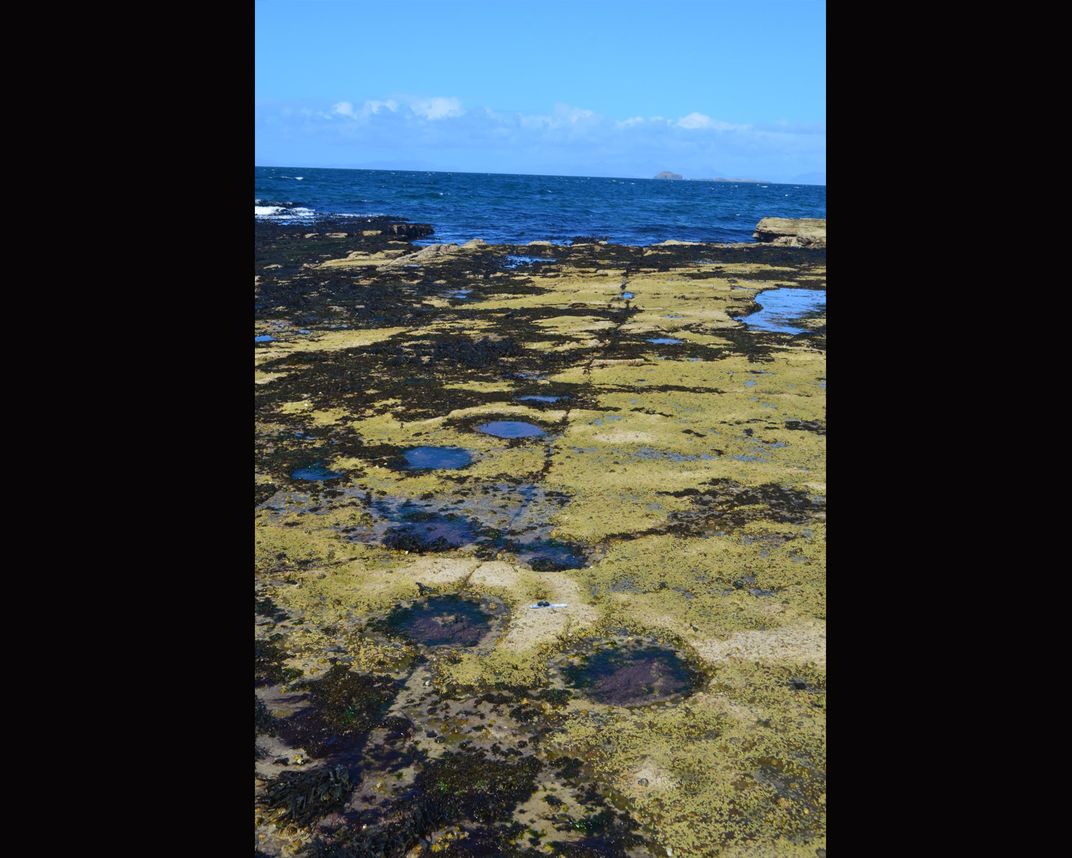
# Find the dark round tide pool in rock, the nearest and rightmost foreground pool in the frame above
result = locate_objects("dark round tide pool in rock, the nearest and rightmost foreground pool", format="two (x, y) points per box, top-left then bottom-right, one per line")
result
(562, 639), (703, 706)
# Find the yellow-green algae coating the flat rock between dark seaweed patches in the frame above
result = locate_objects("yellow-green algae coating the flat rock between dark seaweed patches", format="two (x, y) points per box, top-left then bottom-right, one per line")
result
(256, 231), (825, 856)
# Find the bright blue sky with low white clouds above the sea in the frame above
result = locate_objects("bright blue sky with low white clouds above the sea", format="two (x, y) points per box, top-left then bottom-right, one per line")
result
(255, 0), (827, 182)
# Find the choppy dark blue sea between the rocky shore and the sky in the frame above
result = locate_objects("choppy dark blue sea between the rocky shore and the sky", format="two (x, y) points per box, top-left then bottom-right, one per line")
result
(254, 167), (827, 245)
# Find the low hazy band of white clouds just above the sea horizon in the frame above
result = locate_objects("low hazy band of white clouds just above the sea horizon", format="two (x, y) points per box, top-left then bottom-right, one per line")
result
(257, 93), (827, 181)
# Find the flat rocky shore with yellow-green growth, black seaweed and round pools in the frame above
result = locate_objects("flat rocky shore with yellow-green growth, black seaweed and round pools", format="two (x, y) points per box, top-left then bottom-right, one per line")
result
(254, 218), (825, 856)
